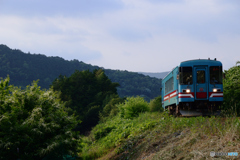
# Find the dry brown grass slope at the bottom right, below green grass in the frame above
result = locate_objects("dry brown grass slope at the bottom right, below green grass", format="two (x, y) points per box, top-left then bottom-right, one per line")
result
(100, 129), (240, 160)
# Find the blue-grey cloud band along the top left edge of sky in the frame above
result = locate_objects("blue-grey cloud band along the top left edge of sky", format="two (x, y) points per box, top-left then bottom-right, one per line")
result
(0, 0), (122, 17)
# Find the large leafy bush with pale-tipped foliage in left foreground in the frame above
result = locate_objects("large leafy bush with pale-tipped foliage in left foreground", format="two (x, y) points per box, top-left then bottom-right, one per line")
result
(0, 78), (79, 160)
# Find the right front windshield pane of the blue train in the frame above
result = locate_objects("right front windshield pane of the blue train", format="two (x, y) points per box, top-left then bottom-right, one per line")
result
(210, 66), (222, 84)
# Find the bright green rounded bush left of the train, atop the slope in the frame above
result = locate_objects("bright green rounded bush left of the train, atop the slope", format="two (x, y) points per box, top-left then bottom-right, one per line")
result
(119, 96), (149, 119)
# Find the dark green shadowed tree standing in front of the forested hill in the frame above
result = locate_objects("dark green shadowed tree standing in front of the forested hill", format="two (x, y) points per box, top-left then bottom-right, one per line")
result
(52, 69), (119, 132)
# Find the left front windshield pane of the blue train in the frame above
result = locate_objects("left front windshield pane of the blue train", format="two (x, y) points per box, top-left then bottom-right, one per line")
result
(179, 67), (192, 85)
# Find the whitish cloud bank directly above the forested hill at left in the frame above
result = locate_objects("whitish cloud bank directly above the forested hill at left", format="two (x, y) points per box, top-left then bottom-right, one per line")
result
(0, 16), (102, 62)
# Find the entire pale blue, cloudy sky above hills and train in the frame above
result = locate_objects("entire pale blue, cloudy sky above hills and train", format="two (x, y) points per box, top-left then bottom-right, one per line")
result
(0, 0), (240, 72)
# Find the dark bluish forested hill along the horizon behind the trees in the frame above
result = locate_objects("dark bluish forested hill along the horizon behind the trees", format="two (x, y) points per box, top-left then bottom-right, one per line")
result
(0, 45), (161, 100)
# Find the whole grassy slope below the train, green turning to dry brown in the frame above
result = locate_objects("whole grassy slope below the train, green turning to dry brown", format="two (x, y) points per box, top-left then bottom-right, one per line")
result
(79, 112), (240, 159)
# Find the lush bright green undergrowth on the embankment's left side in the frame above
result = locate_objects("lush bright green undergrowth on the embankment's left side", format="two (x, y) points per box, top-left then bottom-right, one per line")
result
(80, 112), (159, 159)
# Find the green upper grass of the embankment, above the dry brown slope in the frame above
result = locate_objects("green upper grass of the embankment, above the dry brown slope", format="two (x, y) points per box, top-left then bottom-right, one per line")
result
(79, 112), (240, 159)
